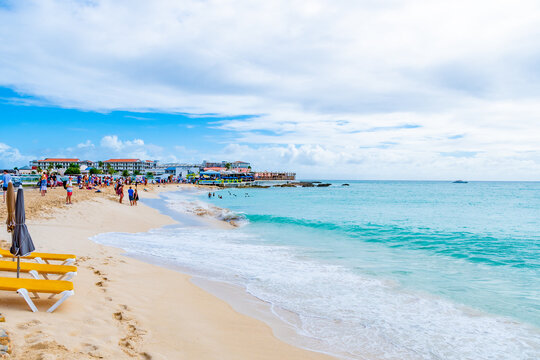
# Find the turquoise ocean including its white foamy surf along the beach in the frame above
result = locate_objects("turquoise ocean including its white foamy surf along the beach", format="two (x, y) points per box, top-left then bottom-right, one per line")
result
(94, 181), (540, 359)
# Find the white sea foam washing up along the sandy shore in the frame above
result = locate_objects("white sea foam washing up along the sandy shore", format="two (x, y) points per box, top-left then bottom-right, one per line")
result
(94, 191), (540, 360)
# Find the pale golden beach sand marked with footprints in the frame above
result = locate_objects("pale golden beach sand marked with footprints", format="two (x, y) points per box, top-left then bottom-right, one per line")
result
(0, 185), (336, 360)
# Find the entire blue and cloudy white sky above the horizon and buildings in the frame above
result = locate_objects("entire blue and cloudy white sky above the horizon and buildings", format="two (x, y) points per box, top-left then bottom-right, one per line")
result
(0, 0), (540, 180)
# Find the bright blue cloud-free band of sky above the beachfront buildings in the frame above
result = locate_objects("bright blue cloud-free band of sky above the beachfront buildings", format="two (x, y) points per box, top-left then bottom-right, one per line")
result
(0, 88), (243, 162)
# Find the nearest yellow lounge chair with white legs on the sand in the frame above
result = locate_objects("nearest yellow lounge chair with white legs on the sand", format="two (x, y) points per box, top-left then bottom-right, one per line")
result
(0, 277), (75, 312)
